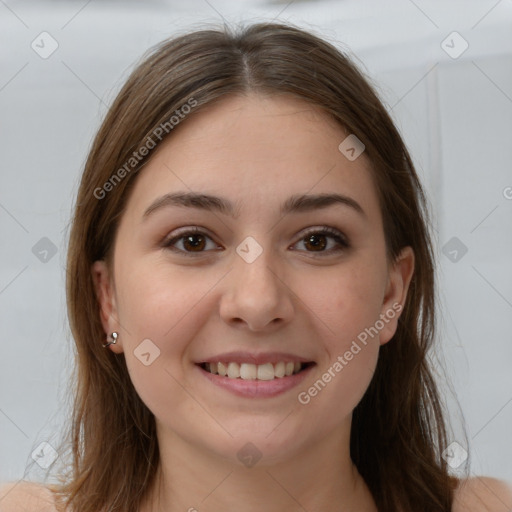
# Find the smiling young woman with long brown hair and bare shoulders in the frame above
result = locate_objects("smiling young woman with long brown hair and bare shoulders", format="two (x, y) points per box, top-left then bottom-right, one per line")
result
(4, 24), (512, 512)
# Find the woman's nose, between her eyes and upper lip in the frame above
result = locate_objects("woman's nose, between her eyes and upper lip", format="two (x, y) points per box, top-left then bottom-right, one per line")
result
(220, 245), (294, 332)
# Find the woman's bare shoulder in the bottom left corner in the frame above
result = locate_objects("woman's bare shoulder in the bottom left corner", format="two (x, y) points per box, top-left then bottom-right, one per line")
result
(0, 480), (58, 512)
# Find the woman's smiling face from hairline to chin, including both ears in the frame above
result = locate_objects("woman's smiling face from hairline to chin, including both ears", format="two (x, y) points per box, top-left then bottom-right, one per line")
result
(93, 95), (413, 463)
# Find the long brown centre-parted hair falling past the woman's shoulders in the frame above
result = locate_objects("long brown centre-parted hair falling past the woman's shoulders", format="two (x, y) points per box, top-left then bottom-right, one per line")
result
(57, 23), (457, 512)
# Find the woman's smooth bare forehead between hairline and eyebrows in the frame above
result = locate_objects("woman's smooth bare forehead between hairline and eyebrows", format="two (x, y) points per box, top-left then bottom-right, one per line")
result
(124, 94), (378, 221)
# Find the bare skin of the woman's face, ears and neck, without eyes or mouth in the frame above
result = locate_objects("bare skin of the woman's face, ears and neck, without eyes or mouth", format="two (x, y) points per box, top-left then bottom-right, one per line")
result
(92, 94), (414, 512)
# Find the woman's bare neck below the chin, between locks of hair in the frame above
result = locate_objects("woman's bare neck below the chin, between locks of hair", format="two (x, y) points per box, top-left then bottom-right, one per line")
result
(140, 420), (377, 512)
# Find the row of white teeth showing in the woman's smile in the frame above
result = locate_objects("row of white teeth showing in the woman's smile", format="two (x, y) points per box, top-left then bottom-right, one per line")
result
(204, 361), (302, 380)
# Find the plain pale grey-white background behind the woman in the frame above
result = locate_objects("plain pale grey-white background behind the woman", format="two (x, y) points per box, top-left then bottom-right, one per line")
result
(0, 0), (512, 488)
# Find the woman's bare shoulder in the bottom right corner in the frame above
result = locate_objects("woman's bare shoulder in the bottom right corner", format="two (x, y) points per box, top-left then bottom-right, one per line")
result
(452, 476), (512, 512)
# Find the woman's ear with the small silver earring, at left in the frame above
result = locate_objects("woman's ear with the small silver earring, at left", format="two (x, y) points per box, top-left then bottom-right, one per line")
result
(91, 260), (123, 354)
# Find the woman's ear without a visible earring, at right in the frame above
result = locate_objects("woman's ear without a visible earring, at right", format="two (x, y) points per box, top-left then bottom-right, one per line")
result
(379, 246), (415, 345)
